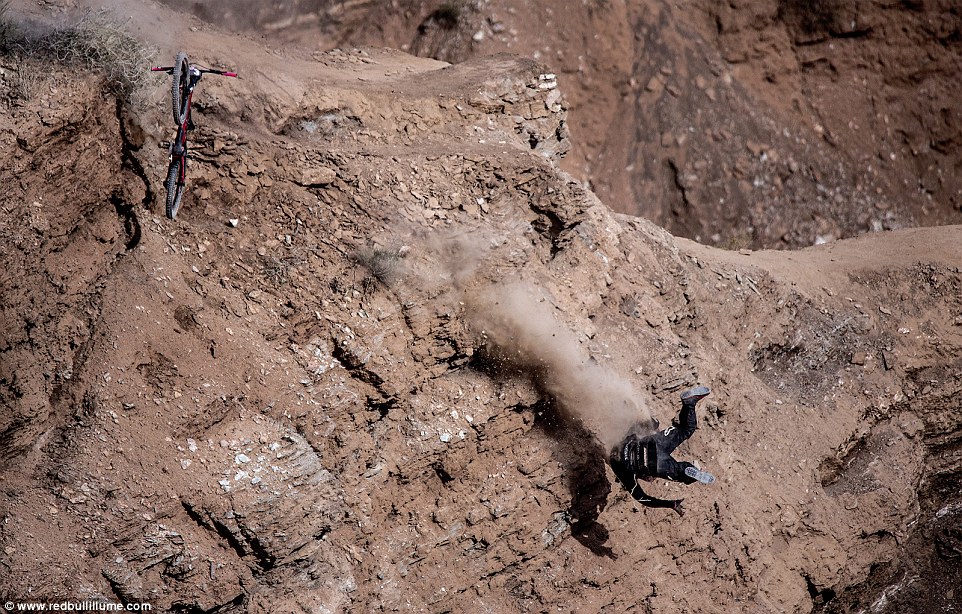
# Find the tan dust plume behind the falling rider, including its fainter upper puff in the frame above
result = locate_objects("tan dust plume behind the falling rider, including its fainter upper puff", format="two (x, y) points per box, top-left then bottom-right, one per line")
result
(399, 233), (655, 448)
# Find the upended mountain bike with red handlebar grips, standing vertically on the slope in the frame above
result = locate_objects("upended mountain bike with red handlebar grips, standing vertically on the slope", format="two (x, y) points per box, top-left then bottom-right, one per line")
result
(150, 51), (237, 220)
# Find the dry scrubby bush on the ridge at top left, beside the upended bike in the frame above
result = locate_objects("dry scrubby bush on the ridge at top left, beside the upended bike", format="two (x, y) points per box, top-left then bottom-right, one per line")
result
(0, 2), (153, 101)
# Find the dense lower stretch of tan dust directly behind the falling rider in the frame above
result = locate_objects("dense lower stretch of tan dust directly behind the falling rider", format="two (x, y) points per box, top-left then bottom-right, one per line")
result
(464, 283), (653, 448)
